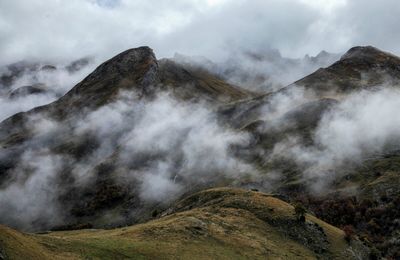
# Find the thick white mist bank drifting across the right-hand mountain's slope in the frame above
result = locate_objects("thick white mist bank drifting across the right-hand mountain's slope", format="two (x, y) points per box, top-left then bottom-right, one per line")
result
(267, 85), (400, 193)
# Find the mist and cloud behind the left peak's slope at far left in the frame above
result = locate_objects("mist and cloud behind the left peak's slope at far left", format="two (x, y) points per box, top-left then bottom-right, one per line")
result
(0, 59), (95, 121)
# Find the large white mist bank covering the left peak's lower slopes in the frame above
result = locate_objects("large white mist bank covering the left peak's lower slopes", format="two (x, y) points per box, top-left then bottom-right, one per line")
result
(0, 92), (256, 230)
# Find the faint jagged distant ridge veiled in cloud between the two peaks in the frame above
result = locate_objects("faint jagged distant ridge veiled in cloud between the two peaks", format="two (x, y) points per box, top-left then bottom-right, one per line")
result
(173, 48), (340, 94)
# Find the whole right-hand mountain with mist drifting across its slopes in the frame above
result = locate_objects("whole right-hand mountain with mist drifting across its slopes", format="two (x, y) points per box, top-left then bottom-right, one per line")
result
(223, 47), (400, 259)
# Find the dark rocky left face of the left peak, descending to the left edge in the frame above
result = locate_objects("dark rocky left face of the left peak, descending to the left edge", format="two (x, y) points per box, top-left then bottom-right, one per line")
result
(0, 47), (158, 137)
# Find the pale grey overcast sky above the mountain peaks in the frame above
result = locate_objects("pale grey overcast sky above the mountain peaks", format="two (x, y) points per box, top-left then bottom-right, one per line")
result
(0, 0), (400, 64)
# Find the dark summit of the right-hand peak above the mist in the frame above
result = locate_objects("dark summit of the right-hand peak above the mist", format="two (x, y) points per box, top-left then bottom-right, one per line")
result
(294, 46), (400, 95)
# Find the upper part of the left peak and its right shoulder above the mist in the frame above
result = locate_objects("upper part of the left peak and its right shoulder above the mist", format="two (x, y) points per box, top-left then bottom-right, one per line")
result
(0, 47), (250, 136)
